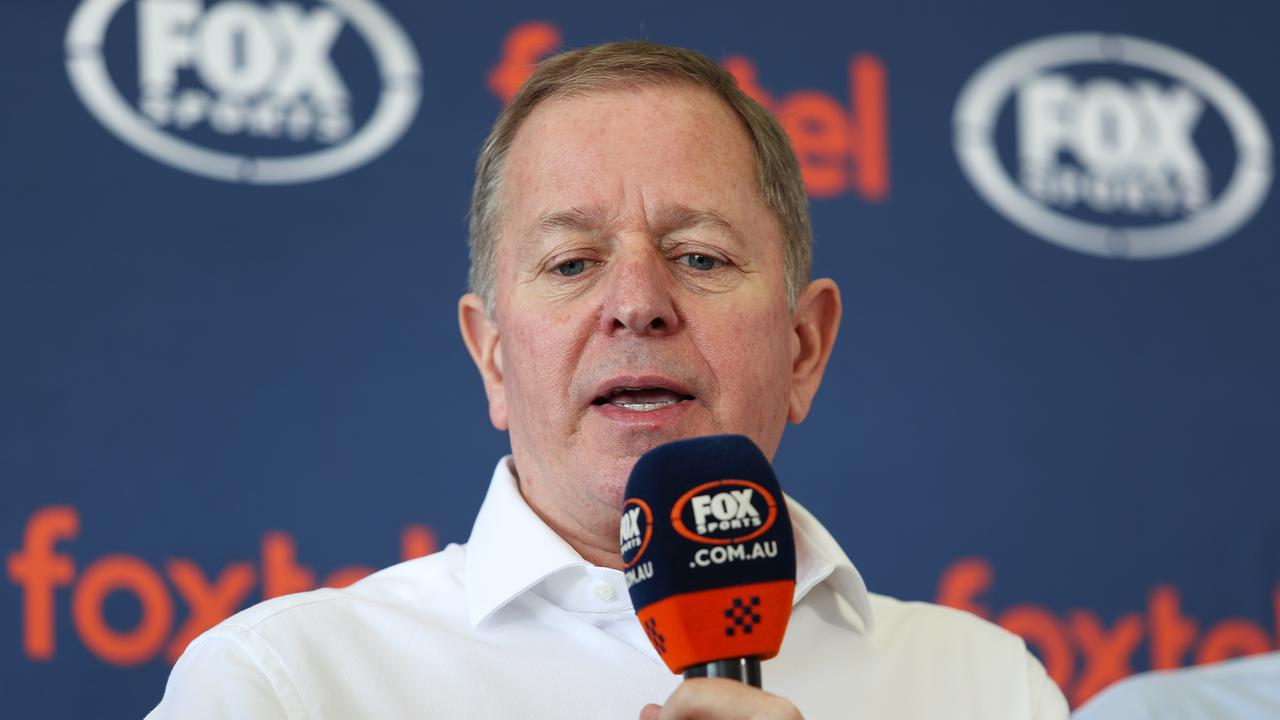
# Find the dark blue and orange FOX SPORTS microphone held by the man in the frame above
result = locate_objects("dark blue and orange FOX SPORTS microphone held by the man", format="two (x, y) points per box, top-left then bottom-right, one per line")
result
(618, 436), (796, 687)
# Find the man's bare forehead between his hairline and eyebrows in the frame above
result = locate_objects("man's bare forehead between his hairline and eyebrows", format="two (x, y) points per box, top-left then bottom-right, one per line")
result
(502, 83), (765, 232)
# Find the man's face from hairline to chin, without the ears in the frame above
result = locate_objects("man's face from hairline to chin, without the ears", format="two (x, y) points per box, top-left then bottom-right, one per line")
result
(463, 85), (819, 545)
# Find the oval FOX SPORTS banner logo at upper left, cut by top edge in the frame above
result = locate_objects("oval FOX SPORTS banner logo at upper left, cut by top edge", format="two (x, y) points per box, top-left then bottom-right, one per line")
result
(67, 0), (421, 184)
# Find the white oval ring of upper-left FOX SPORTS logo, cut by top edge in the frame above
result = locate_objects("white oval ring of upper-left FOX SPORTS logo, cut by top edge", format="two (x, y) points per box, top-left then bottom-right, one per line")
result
(67, 0), (422, 184)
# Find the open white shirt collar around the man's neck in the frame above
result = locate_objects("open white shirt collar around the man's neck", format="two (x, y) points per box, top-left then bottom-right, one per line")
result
(466, 455), (872, 630)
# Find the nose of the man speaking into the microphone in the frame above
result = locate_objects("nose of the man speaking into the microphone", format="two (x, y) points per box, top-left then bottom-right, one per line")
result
(600, 243), (680, 337)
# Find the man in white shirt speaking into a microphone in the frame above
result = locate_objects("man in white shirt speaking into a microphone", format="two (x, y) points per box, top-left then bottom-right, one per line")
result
(152, 44), (1066, 720)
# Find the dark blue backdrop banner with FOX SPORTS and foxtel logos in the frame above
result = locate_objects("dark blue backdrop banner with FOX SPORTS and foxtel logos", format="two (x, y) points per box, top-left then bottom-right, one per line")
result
(0, 0), (1280, 717)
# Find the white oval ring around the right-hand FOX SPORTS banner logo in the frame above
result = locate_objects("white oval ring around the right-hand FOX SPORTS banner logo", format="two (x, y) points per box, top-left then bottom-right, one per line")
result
(951, 32), (1272, 260)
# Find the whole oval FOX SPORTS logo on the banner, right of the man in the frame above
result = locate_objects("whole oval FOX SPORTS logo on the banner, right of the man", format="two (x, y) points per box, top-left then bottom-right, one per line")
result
(952, 33), (1271, 260)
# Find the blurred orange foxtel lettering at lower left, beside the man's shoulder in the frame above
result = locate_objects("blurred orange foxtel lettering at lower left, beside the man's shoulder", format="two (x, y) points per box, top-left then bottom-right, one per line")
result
(5, 505), (436, 666)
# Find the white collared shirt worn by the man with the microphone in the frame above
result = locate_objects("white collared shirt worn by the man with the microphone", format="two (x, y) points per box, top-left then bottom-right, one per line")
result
(147, 457), (1066, 720)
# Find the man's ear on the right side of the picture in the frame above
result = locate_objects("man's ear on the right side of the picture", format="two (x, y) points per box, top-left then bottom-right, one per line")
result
(787, 278), (841, 423)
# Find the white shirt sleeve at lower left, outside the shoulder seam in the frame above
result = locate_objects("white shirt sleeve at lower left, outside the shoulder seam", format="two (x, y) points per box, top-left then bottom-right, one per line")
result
(145, 633), (306, 720)
